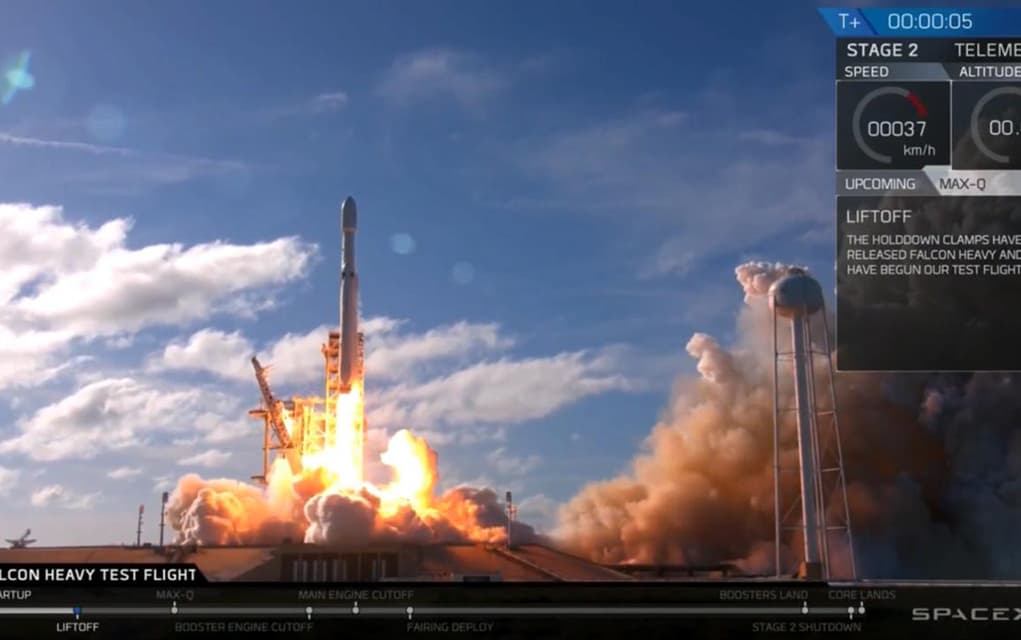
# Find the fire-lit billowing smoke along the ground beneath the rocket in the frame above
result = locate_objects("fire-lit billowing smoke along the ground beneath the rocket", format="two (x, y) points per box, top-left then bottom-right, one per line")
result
(166, 449), (542, 546)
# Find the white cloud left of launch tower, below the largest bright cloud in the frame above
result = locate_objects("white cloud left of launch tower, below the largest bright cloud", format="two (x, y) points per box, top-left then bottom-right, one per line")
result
(0, 378), (244, 461)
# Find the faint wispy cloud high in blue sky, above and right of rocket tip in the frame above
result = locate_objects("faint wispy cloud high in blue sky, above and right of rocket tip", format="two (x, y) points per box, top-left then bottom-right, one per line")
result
(379, 49), (507, 107)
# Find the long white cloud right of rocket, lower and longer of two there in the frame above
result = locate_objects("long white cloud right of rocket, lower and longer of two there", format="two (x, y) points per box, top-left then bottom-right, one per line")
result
(371, 349), (634, 430)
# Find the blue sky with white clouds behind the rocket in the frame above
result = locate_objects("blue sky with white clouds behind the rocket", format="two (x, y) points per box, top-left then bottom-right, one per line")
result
(0, 0), (845, 544)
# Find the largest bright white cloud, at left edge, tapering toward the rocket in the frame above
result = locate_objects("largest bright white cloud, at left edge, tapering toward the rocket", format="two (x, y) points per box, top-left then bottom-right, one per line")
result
(0, 203), (317, 389)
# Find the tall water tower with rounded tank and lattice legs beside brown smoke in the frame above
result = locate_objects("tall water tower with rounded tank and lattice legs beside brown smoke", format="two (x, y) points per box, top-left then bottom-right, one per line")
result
(769, 267), (857, 580)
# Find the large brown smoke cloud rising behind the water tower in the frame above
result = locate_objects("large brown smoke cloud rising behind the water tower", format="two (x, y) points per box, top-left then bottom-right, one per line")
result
(555, 262), (1021, 579)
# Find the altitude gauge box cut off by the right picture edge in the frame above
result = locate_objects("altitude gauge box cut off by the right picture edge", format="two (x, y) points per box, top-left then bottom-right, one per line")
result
(954, 83), (1021, 169)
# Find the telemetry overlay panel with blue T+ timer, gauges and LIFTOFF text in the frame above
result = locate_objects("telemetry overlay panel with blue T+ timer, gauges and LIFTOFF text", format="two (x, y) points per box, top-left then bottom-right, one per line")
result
(820, 8), (1021, 371)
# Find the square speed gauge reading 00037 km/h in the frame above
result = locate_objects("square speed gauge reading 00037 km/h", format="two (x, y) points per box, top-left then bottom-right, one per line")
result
(837, 82), (951, 169)
